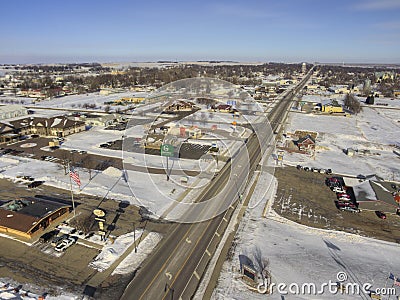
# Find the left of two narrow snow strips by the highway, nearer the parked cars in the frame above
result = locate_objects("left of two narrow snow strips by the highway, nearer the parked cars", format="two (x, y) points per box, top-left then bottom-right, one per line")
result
(89, 230), (143, 272)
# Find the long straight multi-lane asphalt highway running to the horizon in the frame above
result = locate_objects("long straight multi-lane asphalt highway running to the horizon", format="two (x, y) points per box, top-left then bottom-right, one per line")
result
(121, 68), (311, 300)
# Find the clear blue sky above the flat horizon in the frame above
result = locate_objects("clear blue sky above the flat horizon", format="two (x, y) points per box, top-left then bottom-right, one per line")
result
(0, 0), (400, 63)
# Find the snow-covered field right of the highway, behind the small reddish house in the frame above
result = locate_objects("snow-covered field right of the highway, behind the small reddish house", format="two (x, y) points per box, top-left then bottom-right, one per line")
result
(284, 103), (400, 180)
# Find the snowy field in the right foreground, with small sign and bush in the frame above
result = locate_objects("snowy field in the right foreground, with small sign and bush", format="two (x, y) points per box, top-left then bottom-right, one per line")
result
(212, 169), (400, 300)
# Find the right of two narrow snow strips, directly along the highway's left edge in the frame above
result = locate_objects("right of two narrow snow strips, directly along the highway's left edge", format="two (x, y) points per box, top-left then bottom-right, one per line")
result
(112, 232), (162, 275)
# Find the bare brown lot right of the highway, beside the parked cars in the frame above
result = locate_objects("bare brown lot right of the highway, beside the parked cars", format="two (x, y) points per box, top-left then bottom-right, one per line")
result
(273, 167), (400, 243)
